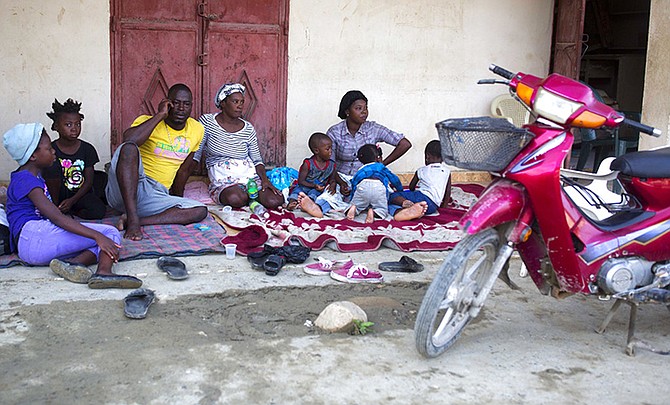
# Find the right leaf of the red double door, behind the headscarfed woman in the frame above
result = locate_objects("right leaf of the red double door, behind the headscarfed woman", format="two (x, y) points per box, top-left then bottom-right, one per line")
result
(203, 0), (288, 165)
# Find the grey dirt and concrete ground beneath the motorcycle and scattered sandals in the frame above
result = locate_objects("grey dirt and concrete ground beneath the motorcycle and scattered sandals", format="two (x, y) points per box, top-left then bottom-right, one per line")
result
(0, 250), (670, 404)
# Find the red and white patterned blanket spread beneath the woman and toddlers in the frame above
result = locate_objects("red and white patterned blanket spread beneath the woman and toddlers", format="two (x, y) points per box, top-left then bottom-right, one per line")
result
(210, 184), (483, 252)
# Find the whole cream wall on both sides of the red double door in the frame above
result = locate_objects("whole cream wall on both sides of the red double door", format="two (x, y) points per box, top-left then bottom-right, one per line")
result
(0, 0), (553, 181)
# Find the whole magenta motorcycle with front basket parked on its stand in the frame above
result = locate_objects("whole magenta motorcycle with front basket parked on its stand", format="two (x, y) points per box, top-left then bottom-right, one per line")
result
(414, 65), (670, 357)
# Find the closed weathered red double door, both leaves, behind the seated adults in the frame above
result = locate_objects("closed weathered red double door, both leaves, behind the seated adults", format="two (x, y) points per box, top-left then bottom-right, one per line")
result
(110, 0), (288, 165)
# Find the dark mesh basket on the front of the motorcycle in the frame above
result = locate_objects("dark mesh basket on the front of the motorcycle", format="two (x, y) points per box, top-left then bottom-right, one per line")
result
(435, 117), (533, 172)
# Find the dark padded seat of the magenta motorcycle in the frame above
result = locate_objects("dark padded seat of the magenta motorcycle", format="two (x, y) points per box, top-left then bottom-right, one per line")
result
(610, 147), (670, 179)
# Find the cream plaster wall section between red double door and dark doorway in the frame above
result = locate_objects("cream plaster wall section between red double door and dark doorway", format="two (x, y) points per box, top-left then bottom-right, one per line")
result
(287, 0), (553, 172)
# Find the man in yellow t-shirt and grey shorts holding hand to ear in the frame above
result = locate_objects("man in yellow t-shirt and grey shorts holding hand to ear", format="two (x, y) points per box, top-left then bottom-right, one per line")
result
(106, 83), (207, 240)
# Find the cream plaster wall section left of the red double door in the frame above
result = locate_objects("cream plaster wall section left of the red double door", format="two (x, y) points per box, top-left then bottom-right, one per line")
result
(0, 0), (110, 181)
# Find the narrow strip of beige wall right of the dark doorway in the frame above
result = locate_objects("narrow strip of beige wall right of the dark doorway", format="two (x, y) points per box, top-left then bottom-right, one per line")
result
(640, 0), (670, 149)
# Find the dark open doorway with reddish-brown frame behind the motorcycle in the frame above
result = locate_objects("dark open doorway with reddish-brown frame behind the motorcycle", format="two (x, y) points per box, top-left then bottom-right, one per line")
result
(552, 0), (650, 171)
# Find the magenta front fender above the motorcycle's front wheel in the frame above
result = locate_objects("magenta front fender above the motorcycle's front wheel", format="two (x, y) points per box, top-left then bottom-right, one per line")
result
(458, 180), (532, 242)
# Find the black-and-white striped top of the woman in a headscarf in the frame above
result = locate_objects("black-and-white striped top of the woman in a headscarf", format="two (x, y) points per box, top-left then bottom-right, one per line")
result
(193, 113), (263, 168)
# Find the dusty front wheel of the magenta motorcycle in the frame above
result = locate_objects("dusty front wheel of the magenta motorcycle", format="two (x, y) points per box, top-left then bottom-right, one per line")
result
(414, 229), (500, 357)
